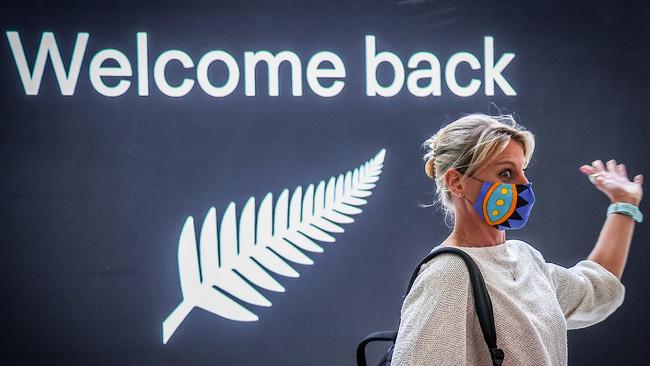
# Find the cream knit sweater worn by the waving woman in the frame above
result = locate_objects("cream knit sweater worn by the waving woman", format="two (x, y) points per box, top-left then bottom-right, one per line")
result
(392, 240), (625, 366)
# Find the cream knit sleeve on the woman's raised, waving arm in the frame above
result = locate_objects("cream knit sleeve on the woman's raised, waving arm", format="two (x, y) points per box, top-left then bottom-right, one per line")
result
(546, 259), (625, 329)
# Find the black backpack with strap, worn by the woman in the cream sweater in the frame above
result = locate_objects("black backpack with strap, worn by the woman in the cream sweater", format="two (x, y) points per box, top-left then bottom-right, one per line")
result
(357, 247), (504, 366)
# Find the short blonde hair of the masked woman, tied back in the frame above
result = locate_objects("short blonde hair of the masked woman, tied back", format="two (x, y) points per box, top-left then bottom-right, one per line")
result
(422, 113), (535, 227)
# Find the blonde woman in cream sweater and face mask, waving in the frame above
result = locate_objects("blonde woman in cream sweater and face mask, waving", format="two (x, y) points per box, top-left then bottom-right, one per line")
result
(392, 114), (643, 366)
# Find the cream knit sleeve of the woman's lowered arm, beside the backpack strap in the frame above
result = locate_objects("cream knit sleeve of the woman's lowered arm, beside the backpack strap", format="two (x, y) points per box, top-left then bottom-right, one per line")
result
(391, 254), (471, 366)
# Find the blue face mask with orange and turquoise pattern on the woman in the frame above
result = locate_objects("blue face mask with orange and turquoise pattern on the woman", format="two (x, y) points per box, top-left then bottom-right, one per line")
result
(463, 177), (535, 230)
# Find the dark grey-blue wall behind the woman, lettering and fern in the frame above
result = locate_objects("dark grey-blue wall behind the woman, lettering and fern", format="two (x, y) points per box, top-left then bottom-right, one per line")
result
(0, 0), (650, 365)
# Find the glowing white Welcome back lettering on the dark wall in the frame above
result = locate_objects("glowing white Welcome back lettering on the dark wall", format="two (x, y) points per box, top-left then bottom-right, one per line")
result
(6, 31), (517, 98)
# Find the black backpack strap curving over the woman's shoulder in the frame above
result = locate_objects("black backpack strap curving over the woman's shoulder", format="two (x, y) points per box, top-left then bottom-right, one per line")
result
(404, 246), (505, 366)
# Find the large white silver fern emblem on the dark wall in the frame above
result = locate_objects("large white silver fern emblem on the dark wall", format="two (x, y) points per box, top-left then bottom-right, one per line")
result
(162, 149), (386, 343)
